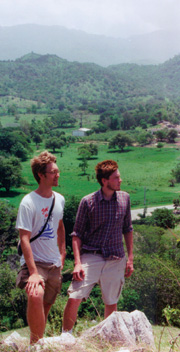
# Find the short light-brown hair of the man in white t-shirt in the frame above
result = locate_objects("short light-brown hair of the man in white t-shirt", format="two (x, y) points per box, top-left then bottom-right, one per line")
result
(31, 150), (56, 183)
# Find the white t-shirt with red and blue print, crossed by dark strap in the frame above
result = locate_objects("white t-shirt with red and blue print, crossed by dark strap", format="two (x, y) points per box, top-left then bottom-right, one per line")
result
(16, 191), (65, 267)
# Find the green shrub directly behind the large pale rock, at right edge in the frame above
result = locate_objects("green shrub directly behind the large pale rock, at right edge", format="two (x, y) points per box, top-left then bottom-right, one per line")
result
(122, 253), (180, 324)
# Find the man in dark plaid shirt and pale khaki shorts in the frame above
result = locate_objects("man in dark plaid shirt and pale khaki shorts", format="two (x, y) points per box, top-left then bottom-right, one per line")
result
(63, 160), (133, 332)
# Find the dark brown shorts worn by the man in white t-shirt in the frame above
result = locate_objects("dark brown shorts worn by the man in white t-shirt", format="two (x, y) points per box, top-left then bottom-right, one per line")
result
(16, 262), (62, 304)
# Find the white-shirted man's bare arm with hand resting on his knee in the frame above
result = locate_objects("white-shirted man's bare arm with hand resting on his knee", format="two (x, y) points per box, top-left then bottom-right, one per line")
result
(19, 229), (44, 295)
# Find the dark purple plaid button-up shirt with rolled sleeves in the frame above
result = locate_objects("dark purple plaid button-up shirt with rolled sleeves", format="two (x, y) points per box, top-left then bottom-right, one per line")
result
(71, 190), (132, 259)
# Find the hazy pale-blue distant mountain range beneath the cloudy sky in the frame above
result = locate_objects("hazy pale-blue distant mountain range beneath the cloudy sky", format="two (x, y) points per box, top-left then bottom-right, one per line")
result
(0, 24), (180, 67)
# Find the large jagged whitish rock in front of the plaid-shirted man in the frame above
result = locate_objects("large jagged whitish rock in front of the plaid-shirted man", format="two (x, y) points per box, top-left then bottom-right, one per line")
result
(81, 310), (154, 348)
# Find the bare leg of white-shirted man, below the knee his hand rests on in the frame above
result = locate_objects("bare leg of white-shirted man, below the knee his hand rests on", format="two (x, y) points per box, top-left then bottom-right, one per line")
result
(27, 285), (45, 344)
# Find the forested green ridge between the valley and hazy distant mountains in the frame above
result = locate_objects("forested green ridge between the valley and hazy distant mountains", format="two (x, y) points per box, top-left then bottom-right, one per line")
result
(0, 53), (180, 107)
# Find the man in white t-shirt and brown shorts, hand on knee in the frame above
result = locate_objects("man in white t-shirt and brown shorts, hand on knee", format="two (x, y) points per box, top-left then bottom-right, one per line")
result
(16, 151), (66, 344)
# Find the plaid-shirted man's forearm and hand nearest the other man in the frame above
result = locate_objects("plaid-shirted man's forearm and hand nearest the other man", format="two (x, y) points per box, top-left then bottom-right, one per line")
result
(72, 236), (84, 281)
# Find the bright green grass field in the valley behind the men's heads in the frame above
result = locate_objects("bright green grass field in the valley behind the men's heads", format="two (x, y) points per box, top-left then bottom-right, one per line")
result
(0, 143), (180, 208)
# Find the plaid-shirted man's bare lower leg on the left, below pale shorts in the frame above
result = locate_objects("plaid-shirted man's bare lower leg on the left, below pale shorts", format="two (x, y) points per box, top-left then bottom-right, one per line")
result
(63, 298), (81, 331)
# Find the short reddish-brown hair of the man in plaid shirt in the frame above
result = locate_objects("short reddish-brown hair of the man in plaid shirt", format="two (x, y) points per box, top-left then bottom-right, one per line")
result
(95, 160), (118, 186)
